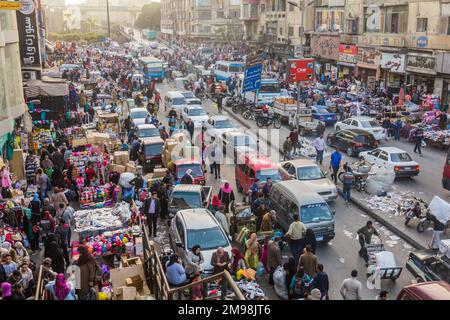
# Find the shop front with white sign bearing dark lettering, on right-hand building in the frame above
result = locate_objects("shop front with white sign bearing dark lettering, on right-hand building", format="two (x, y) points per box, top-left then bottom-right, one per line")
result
(380, 52), (406, 94)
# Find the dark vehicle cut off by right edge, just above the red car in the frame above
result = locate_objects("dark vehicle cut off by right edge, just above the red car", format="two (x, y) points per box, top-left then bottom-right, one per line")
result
(406, 249), (450, 283)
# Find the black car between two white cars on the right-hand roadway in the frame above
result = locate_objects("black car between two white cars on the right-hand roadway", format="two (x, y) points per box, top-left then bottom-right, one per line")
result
(327, 129), (378, 157)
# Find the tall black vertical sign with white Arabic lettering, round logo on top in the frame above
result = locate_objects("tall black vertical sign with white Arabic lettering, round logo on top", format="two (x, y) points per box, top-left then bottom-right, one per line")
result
(16, 0), (41, 68)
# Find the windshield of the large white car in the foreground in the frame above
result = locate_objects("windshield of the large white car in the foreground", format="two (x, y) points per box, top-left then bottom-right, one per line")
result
(187, 227), (229, 250)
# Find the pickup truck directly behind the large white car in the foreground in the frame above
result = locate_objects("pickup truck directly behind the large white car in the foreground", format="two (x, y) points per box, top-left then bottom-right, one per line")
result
(169, 184), (212, 218)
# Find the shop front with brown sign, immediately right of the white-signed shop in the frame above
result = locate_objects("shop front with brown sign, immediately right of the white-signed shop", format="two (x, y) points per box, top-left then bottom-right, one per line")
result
(406, 53), (436, 94)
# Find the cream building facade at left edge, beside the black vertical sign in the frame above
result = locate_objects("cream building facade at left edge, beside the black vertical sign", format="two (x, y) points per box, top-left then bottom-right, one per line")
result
(0, 11), (25, 142)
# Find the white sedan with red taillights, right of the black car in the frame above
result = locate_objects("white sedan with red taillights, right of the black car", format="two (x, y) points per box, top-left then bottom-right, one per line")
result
(359, 147), (420, 177)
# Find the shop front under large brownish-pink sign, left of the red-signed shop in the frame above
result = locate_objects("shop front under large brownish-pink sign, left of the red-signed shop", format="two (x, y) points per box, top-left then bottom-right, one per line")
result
(311, 34), (340, 79)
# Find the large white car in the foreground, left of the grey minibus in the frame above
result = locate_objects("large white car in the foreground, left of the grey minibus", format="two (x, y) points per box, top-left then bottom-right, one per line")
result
(169, 209), (231, 274)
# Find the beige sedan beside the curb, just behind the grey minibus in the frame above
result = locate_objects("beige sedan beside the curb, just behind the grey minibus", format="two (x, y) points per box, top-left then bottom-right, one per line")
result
(278, 159), (337, 201)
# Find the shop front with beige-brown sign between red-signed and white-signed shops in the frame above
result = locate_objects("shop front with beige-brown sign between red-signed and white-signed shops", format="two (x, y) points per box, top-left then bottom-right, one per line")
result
(356, 47), (381, 90)
